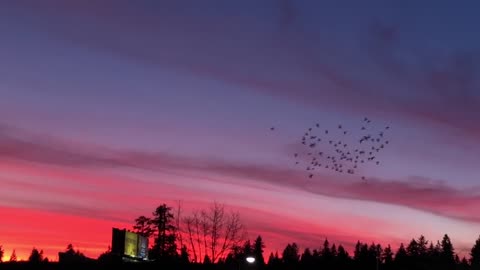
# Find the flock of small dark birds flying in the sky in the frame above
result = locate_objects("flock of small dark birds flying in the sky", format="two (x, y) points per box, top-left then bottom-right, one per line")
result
(270, 117), (390, 180)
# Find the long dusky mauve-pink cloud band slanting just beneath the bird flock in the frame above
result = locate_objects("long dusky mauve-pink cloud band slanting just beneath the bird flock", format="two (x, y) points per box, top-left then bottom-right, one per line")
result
(0, 124), (480, 222)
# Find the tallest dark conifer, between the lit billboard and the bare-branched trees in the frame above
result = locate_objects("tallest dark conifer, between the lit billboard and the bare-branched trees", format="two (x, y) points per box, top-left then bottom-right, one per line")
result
(151, 204), (177, 260)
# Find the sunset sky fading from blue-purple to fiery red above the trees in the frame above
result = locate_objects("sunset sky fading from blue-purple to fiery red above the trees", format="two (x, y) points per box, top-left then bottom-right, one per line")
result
(0, 0), (480, 260)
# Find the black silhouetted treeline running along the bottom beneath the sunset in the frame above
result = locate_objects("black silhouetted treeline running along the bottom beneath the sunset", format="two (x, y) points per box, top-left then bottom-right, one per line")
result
(0, 202), (480, 270)
